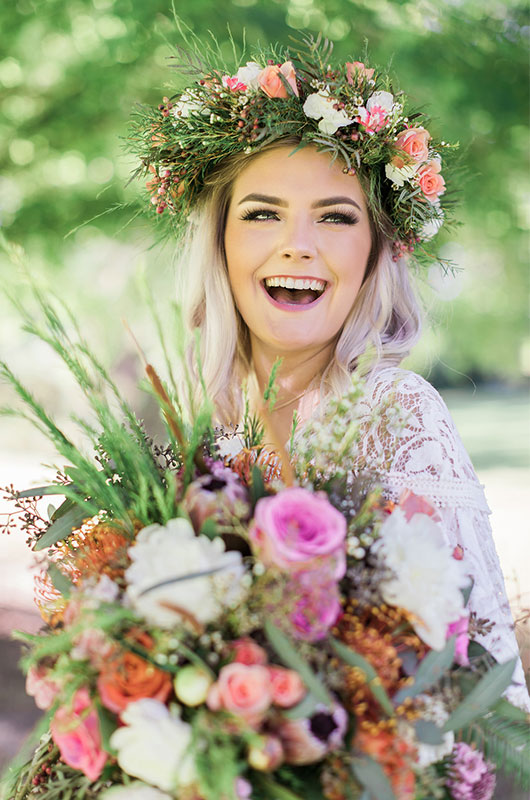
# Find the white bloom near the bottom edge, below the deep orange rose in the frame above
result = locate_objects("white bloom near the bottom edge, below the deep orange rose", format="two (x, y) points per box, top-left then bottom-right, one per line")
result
(110, 698), (196, 792)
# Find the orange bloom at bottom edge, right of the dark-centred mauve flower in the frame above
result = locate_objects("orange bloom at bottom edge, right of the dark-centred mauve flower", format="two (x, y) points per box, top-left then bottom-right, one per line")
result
(353, 730), (415, 800)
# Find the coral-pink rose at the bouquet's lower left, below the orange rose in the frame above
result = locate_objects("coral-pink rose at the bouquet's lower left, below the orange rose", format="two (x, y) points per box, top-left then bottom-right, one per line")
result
(50, 689), (107, 781)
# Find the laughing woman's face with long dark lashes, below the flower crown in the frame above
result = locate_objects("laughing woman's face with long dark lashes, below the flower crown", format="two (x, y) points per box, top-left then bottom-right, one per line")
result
(225, 145), (371, 354)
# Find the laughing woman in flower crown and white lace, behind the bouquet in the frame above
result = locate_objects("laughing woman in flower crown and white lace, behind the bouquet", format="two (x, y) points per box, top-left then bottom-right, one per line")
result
(132, 43), (530, 707)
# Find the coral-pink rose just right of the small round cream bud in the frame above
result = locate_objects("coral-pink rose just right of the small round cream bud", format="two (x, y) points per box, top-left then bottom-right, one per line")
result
(206, 663), (272, 727)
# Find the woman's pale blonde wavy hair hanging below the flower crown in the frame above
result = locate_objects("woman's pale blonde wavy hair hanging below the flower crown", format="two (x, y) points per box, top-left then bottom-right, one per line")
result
(177, 138), (422, 425)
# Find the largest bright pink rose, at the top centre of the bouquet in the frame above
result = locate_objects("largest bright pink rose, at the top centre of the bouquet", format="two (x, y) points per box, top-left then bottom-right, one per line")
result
(249, 487), (346, 580)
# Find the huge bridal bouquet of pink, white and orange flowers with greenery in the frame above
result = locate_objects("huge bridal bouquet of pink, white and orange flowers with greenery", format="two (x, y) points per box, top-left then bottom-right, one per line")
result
(1, 298), (530, 800)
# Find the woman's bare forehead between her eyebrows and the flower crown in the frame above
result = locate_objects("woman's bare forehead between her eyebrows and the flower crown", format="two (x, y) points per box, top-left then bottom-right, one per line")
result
(232, 145), (365, 206)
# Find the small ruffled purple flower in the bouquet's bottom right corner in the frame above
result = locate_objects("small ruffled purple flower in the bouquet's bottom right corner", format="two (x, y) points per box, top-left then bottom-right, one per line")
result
(447, 742), (495, 800)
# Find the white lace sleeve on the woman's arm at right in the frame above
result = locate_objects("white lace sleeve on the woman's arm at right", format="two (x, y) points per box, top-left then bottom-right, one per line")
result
(363, 369), (530, 710)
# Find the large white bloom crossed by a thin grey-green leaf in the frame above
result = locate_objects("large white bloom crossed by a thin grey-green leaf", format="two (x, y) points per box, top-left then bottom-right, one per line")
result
(125, 518), (244, 628)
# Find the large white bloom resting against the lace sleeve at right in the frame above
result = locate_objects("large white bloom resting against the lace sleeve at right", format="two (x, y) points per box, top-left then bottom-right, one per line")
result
(373, 508), (469, 650)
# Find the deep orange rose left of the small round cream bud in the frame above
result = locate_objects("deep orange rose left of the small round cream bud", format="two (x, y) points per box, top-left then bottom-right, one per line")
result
(97, 633), (172, 714)
